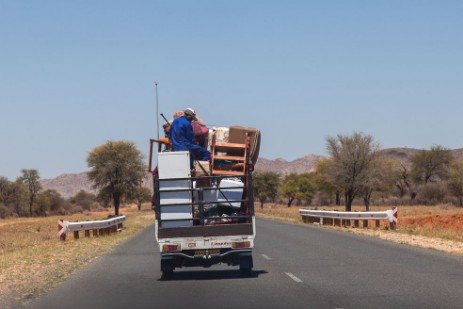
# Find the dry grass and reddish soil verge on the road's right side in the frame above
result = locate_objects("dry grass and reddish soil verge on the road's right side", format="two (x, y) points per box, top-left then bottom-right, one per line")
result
(256, 204), (463, 255)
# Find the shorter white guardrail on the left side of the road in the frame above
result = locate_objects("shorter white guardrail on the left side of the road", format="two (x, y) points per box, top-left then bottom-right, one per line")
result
(58, 216), (125, 240)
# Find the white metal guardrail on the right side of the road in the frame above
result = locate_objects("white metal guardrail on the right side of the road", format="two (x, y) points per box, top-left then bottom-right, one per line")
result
(299, 207), (398, 230)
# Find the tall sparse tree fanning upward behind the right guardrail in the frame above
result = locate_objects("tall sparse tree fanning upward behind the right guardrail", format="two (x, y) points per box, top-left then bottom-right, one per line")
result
(326, 132), (379, 211)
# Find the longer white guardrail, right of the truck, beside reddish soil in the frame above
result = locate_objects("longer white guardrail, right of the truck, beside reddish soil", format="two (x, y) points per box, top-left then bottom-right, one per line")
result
(299, 207), (398, 228)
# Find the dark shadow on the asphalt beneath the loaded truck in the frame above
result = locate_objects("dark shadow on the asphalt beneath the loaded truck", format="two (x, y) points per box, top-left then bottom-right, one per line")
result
(158, 269), (268, 281)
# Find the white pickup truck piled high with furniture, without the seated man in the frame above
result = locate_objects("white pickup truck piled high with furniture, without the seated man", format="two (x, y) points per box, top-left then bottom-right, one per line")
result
(149, 127), (260, 278)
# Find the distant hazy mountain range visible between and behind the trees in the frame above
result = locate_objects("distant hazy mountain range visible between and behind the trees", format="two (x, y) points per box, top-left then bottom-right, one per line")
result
(41, 148), (463, 198)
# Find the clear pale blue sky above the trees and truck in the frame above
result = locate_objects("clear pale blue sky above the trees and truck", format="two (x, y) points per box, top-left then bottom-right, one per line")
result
(0, 0), (463, 180)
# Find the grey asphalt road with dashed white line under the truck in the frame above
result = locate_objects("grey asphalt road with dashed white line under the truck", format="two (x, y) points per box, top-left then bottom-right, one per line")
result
(28, 219), (463, 309)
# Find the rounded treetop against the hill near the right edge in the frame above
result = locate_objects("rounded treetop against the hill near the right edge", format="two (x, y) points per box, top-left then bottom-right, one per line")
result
(411, 145), (453, 184)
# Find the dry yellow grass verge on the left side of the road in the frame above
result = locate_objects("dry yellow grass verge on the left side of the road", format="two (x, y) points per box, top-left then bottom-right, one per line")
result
(0, 205), (154, 307)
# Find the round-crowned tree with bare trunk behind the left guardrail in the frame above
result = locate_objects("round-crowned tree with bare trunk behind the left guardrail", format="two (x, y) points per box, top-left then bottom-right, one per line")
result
(87, 141), (146, 216)
